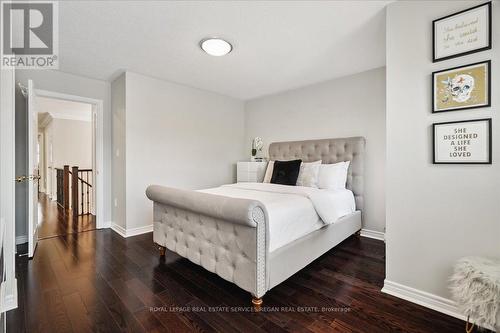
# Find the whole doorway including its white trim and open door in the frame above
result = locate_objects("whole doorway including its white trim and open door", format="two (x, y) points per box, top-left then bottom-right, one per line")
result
(16, 84), (104, 258)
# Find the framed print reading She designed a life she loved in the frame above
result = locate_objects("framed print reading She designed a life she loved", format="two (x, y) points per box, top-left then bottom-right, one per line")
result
(432, 118), (492, 164)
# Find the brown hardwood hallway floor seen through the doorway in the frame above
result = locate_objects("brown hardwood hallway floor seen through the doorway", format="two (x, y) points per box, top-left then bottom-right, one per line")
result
(38, 193), (95, 239)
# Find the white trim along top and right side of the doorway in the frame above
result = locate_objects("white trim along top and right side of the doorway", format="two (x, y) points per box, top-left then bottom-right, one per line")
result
(36, 89), (104, 229)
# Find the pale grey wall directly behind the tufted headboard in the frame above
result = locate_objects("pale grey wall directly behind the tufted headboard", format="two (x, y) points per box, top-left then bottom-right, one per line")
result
(245, 68), (385, 232)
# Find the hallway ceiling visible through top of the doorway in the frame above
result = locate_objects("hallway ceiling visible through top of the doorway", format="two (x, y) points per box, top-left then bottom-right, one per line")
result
(36, 97), (92, 123)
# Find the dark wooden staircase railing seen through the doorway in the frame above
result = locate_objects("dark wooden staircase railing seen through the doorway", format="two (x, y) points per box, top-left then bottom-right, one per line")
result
(56, 165), (94, 216)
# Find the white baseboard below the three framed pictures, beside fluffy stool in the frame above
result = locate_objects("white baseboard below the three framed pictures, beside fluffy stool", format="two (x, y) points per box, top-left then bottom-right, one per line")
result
(382, 279), (467, 320)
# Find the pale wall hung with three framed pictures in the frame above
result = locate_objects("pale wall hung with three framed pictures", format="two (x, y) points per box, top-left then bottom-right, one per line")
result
(386, 1), (500, 298)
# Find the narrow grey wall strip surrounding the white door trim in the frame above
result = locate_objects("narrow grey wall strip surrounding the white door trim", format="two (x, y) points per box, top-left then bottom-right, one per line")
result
(16, 70), (111, 236)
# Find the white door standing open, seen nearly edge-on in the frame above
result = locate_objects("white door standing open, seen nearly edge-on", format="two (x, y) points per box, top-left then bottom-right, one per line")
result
(27, 80), (40, 258)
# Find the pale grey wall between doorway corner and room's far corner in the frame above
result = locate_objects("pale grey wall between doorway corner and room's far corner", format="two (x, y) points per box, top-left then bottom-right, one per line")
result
(113, 72), (244, 229)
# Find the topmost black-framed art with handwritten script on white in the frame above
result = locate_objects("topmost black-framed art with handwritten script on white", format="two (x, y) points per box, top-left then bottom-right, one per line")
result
(432, 2), (492, 62)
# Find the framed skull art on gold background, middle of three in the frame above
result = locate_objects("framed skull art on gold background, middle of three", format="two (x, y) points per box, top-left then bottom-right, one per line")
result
(432, 61), (491, 113)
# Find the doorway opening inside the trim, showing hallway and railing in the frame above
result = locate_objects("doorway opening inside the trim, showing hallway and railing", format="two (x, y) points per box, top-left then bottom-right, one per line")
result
(36, 96), (96, 239)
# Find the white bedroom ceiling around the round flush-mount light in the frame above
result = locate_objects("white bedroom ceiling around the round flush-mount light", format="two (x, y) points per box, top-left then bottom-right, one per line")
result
(59, 0), (391, 100)
